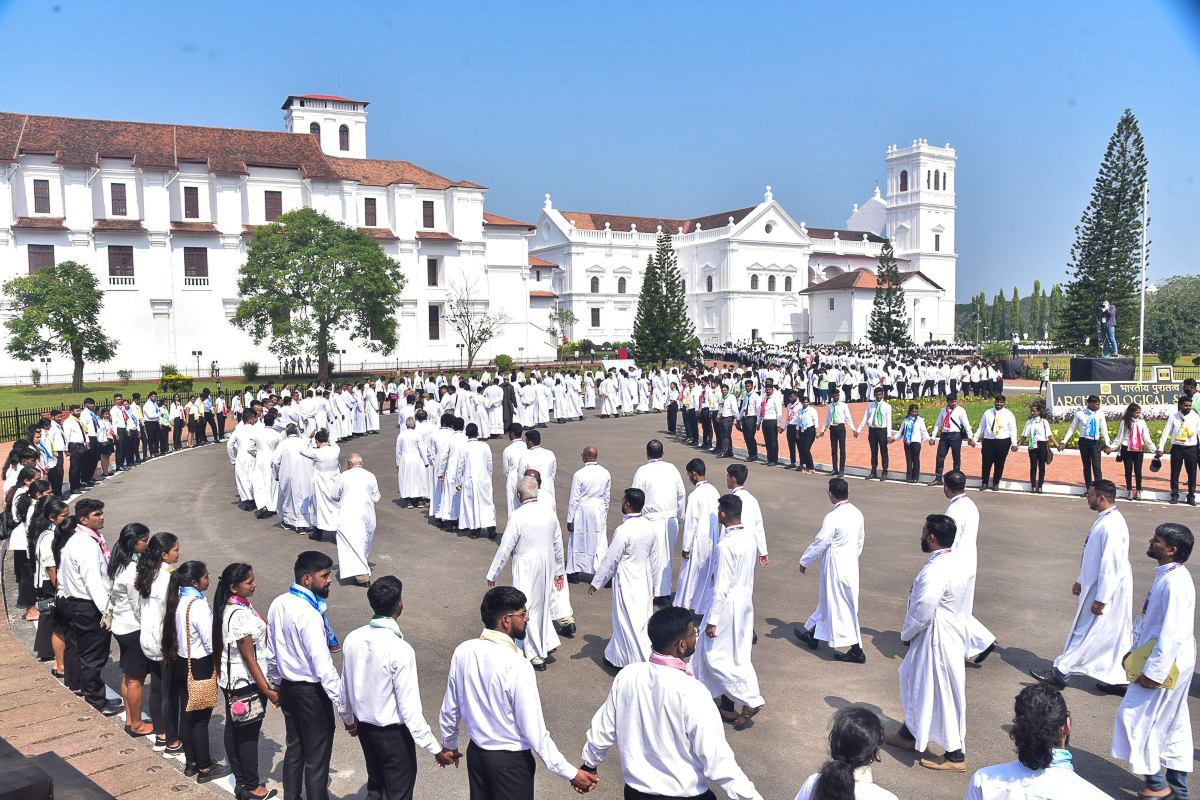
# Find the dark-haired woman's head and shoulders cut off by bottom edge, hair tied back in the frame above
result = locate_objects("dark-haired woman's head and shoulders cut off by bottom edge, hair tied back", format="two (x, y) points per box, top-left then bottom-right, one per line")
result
(796, 705), (896, 800)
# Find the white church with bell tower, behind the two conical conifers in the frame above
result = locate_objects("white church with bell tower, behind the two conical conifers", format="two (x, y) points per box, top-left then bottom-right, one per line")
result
(530, 140), (956, 343)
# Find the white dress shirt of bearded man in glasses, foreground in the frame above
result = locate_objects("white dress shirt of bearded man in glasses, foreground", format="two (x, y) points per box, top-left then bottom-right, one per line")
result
(439, 631), (573, 780)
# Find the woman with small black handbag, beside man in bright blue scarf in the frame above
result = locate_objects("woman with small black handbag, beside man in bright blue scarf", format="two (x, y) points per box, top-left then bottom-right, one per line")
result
(212, 563), (280, 800)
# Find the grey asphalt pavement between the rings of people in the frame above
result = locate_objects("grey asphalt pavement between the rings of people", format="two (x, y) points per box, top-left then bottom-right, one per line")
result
(11, 415), (1196, 800)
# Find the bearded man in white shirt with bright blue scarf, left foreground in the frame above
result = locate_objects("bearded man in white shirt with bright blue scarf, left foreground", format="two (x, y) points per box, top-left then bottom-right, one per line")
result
(266, 551), (358, 800)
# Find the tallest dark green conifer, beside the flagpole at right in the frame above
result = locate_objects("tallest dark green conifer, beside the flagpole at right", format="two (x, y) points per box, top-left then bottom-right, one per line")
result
(1055, 108), (1146, 355)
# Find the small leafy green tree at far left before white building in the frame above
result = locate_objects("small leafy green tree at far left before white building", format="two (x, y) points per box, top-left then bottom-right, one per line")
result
(4, 261), (116, 391)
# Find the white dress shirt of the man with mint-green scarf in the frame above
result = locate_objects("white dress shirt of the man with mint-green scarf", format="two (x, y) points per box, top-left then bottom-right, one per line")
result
(342, 625), (442, 756)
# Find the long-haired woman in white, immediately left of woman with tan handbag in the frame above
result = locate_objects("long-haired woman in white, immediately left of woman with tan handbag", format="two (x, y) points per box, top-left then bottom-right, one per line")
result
(133, 531), (184, 754)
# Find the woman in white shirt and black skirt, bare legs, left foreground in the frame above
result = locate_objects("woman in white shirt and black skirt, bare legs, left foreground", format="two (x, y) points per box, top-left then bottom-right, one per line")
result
(108, 522), (154, 739)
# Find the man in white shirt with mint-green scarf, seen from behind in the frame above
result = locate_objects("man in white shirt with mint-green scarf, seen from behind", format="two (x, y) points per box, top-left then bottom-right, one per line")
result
(342, 575), (454, 799)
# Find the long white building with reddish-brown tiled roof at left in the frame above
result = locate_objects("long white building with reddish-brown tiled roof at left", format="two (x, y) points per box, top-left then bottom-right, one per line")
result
(0, 95), (553, 374)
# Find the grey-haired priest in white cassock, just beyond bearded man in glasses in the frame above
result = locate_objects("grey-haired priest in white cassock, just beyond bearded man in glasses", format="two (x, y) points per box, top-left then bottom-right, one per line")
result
(487, 477), (566, 670)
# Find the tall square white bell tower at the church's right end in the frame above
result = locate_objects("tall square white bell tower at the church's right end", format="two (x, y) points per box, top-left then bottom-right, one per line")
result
(883, 139), (958, 341)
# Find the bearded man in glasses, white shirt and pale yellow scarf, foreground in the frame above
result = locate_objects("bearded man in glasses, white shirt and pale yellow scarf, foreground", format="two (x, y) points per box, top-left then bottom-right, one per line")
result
(438, 587), (596, 800)
